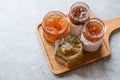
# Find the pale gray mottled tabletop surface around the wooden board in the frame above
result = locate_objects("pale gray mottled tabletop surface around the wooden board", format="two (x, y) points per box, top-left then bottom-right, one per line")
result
(0, 0), (120, 80)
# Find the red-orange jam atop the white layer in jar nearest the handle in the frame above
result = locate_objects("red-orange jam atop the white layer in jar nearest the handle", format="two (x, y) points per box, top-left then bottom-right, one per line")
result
(83, 18), (104, 42)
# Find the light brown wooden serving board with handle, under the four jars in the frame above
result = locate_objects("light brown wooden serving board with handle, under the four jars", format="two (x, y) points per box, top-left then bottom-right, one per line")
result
(36, 13), (120, 74)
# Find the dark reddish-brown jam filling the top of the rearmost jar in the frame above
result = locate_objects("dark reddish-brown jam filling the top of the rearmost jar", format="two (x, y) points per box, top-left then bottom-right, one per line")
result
(69, 2), (90, 25)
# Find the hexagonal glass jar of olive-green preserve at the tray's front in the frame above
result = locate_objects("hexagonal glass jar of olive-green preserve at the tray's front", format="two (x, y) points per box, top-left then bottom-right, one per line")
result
(55, 35), (83, 68)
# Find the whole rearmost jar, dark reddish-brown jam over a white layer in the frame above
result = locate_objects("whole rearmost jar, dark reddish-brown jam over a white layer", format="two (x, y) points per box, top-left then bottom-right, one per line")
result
(69, 2), (90, 36)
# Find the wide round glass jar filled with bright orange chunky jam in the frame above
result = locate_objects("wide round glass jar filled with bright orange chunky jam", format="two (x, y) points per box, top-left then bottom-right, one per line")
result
(42, 11), (68, 44)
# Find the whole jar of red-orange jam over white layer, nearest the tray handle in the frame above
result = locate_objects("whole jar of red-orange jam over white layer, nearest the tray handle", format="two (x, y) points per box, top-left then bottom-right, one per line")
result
(81, 18), (106, 52)
